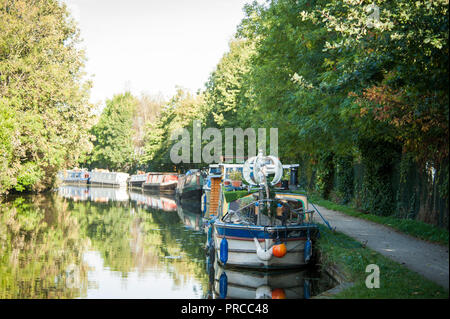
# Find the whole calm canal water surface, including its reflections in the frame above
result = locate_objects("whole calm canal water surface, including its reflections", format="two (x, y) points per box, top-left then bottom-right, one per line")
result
(0, 186), (333, 299)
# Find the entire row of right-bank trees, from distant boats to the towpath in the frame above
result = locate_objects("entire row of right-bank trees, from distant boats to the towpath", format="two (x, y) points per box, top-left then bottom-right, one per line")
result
(97, 0), (449, 230)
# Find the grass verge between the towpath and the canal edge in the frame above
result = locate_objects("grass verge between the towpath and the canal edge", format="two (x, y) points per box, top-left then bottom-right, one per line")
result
(318, 225), (449, 299)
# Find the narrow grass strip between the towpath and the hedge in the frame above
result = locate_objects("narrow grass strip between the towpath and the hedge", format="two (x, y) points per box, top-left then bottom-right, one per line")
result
(308, 195), (448, 246)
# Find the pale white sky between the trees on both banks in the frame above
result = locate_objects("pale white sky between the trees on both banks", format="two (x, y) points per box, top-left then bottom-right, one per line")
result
(63, 0), (250, 104)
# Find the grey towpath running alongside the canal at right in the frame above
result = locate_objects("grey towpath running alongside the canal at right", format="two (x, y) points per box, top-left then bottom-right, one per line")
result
(315, 205), (449, 290)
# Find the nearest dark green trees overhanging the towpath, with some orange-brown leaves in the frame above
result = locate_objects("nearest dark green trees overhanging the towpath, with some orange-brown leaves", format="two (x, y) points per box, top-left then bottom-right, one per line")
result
(232, 0), (448, 225)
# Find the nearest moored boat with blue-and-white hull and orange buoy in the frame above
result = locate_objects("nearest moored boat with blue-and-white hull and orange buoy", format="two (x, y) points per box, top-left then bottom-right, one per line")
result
(205, 153), (319, 269)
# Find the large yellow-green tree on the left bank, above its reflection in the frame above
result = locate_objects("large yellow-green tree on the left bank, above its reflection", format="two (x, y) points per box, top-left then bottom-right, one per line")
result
(0, 0), (92, 194)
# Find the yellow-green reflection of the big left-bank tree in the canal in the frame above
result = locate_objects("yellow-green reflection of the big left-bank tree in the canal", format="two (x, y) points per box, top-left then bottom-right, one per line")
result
(0, 195), (90, 298)
